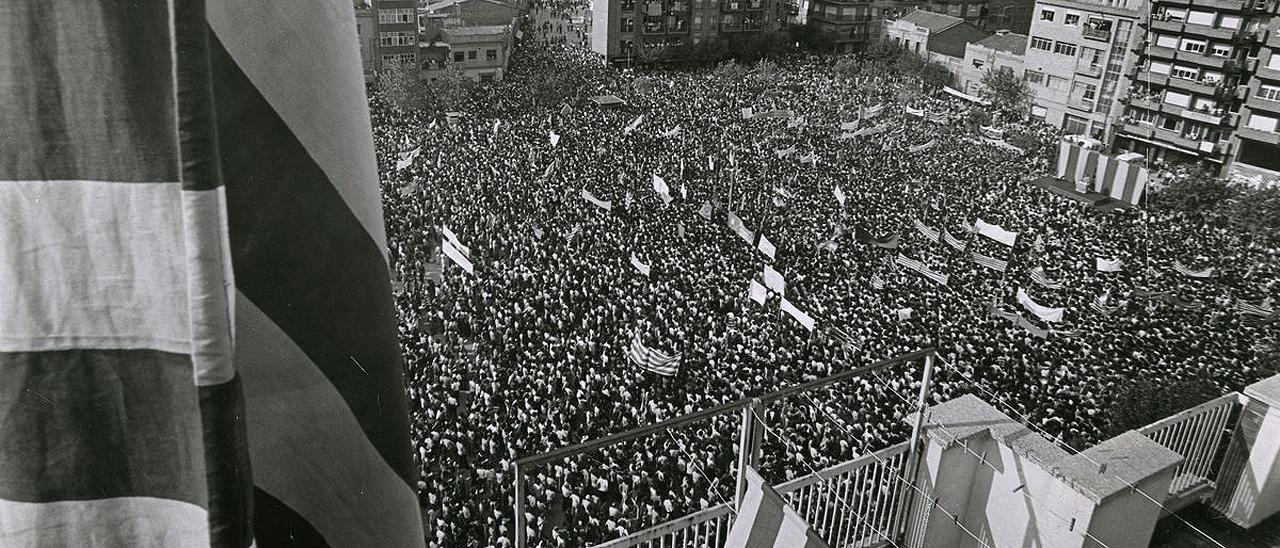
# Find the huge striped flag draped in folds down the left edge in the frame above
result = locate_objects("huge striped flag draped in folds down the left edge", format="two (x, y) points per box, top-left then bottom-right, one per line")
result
(0, 0), (424, 548)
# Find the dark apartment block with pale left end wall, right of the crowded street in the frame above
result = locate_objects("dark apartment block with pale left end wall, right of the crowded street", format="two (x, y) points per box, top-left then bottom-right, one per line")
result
(591, 0), (790, 61)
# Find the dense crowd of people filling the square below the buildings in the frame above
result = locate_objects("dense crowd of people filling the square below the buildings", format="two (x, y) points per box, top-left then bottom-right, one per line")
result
(372, 28), (1280, 547)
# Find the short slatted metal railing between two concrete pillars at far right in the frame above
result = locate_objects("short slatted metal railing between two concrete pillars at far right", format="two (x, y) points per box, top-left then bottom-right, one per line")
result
(1138, 392), (1240, 498)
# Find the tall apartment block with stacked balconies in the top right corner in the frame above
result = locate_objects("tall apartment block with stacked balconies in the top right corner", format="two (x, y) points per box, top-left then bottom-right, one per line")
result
(1115, 0), (1280, 179)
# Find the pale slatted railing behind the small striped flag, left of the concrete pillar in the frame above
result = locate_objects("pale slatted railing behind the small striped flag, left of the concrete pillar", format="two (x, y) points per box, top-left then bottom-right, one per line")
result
(598, 442), (911, 548)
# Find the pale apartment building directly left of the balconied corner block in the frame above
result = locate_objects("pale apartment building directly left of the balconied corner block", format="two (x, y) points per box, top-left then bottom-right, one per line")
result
(1024, 0), (1146, 142)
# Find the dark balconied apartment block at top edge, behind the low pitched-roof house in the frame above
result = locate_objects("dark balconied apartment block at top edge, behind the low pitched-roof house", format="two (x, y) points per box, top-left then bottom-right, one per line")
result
(808, 0), (993, 51)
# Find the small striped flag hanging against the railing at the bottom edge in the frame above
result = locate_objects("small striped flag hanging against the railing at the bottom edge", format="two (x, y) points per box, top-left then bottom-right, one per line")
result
(724, 466), (827, 548)
